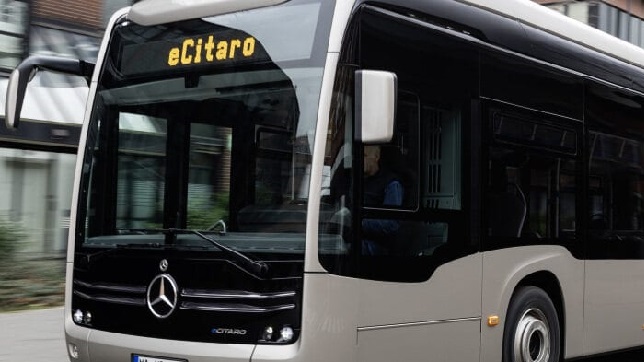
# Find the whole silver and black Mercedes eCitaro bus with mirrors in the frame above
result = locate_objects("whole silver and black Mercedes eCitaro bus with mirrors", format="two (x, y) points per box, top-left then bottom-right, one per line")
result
(6, 0), (644, 362)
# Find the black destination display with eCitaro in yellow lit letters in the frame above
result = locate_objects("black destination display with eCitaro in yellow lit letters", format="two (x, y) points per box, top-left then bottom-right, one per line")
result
(119, 30), (270, 76)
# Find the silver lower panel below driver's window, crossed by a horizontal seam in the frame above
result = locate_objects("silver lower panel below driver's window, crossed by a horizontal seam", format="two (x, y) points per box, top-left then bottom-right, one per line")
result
(357, 254), (482, 362)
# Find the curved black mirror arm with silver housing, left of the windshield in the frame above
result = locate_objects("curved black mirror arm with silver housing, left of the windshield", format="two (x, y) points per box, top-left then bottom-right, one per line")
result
(5, 55), (94, 128)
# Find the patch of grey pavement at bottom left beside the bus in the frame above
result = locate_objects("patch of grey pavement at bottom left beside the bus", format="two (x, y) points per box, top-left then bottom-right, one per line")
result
(0, 307), (69, 362)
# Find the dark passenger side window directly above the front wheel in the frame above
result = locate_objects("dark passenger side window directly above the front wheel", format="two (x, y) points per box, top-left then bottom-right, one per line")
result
(486, 111), (578, 242)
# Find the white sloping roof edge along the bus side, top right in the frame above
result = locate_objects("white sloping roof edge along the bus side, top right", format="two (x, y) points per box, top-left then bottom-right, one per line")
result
(457, 0), (644, 68)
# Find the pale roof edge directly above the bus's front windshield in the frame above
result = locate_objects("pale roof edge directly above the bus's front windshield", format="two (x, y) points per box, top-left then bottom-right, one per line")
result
(128, 0), (288, 26)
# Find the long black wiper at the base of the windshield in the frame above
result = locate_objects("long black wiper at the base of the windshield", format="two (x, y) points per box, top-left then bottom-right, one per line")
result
(118, 228), (268, 278)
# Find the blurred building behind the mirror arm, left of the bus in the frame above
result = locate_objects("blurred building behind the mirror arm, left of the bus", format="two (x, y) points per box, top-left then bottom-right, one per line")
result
(0, 0), (132, 257)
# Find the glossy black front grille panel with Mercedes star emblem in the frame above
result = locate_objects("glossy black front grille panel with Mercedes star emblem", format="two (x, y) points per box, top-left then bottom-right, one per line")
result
(72, 250), (304, 344)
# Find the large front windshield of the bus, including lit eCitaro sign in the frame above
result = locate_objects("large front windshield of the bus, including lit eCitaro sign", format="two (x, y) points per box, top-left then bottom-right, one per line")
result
(76, 0), (332, 252)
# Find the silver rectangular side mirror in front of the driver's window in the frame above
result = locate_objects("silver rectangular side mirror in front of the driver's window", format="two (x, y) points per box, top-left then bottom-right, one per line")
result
(355, 70), (398, 143)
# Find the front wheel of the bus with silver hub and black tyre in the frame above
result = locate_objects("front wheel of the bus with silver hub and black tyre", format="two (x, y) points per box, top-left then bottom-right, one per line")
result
(503, 286), (561, 362)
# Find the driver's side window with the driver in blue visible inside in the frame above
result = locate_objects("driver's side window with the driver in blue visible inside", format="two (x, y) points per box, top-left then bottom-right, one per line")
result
(361, 91), (423, 256)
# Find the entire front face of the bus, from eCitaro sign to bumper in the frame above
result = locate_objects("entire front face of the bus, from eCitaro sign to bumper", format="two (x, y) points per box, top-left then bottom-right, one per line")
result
(65, 0), (342, 362)
